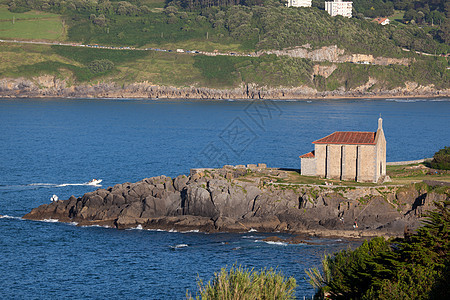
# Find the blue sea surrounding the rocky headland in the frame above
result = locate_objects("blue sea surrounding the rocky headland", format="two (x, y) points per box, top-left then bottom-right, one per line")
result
(0, 98), (450, 299)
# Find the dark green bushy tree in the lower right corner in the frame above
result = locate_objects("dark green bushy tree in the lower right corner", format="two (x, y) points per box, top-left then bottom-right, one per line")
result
(307, 198), (450, 299)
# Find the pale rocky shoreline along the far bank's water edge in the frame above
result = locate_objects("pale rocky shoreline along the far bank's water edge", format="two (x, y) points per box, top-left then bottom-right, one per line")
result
(0, 75), (450, 100)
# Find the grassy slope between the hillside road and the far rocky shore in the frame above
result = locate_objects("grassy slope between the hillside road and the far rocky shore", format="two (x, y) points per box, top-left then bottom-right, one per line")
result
(0, 44), (450, 90)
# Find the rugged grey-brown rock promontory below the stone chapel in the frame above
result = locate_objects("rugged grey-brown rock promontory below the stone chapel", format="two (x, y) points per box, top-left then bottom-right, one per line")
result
(24, 167), (448, 237)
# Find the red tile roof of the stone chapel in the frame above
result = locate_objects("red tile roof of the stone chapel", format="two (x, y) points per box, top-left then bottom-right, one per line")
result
(313, 131), (376, 145)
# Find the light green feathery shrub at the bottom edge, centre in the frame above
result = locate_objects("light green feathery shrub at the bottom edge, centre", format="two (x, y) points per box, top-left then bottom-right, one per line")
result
(188, 266), (297, 300)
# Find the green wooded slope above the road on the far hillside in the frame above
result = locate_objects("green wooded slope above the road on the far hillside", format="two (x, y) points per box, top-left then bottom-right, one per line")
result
(4, 0), (449, 55)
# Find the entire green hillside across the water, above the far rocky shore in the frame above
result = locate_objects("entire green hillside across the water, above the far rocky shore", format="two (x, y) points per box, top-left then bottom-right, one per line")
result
(0, 0), (450, 91)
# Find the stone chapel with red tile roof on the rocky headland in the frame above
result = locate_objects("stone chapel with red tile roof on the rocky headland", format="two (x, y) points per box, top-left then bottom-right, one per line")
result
(300, 118), (386, 182)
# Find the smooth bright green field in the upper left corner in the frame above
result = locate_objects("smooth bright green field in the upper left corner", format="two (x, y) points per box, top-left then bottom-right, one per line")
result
(0, 6), (65, 41)
